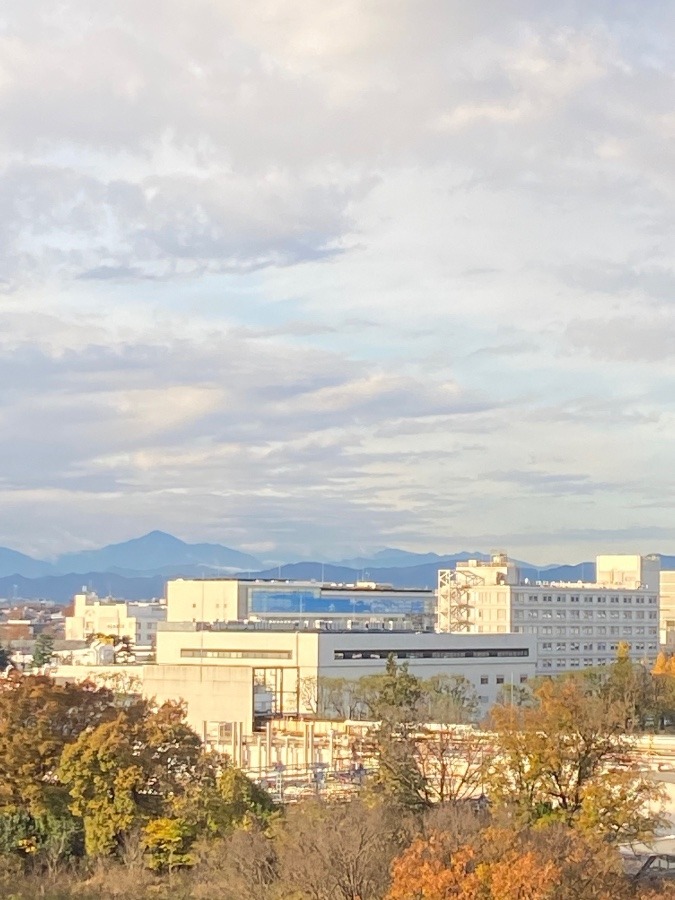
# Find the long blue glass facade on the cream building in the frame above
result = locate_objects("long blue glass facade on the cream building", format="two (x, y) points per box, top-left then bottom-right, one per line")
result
(249, 587), (428, 616)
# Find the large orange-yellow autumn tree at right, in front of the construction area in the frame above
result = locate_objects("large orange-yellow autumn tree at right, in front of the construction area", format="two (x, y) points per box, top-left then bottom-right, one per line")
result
(486, 679), (663, 841)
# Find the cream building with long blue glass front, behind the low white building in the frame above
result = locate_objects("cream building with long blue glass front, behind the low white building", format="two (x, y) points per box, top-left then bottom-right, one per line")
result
(166, 578), (435, 630)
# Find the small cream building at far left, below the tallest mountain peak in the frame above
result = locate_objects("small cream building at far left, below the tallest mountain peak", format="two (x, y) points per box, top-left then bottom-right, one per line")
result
(65, 593), (166, 649)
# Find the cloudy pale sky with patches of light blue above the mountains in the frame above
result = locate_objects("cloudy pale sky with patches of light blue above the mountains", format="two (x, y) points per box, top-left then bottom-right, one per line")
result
(0, 0), (675, 563)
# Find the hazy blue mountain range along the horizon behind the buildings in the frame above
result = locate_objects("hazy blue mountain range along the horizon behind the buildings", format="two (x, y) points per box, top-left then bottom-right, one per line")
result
(0, 531), (675, 603)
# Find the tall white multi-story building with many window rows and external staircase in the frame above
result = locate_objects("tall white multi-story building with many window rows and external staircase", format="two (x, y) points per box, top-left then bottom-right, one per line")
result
(438, 554), (659, 673)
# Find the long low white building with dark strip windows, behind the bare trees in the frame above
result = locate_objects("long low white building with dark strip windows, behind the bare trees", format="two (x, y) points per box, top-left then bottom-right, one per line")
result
(149, 622), (536, 738)
